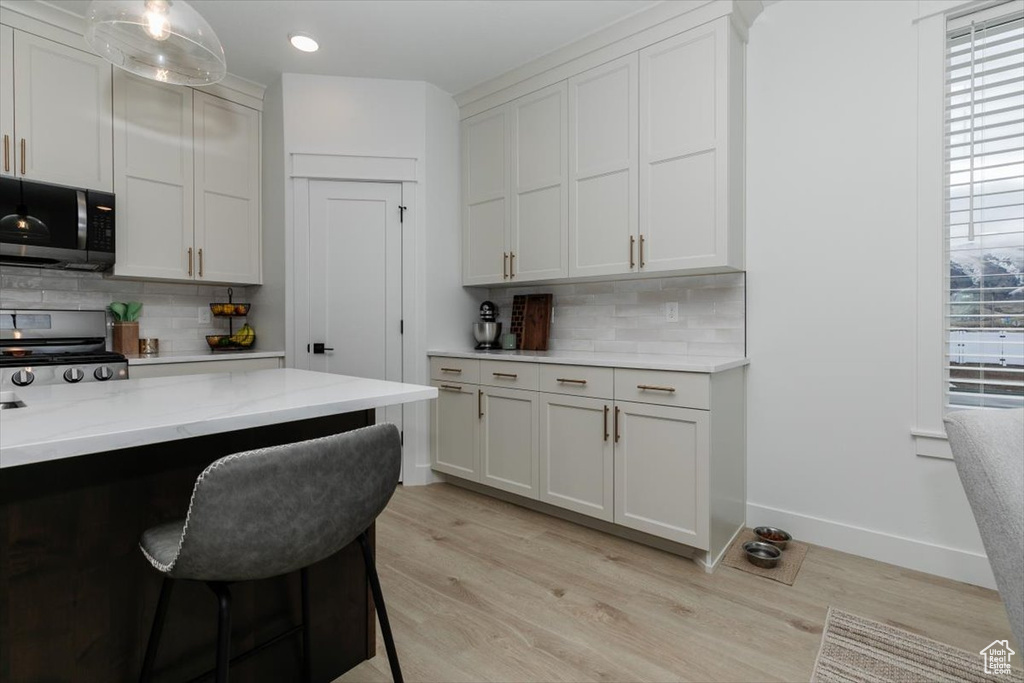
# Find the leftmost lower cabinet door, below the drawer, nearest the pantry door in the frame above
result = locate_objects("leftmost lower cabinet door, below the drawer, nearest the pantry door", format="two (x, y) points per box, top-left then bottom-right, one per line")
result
(431, 382), (480, 481)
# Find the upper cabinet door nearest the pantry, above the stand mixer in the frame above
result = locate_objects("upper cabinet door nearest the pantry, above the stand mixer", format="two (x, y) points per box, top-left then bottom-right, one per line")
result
(462, 106), (509, 285)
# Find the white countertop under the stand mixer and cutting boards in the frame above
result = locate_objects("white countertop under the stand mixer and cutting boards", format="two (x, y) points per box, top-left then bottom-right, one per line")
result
(427, 349), (750, 373)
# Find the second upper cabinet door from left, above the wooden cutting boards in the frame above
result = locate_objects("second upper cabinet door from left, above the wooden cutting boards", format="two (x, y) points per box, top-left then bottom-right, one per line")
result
(508, 82), (568, 282)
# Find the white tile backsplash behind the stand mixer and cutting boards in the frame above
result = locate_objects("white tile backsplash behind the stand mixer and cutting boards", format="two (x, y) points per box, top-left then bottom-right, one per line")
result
(488, 273), (745, 355)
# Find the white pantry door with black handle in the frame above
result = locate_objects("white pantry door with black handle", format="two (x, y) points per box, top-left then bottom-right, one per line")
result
(299, 180), (402, 436)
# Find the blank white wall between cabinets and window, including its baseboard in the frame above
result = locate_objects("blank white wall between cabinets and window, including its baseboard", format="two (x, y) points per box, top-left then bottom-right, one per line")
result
(746, 0), (994, 587)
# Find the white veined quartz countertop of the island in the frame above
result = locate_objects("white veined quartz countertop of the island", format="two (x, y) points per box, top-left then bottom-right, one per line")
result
(0, 369), (437, 468)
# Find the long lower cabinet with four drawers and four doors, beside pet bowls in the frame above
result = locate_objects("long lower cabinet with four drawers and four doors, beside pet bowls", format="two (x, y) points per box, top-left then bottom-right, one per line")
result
(431, 356), (746, 565)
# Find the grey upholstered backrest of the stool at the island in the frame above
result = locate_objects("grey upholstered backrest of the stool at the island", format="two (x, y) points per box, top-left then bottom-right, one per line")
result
(168, 424), (401, 581)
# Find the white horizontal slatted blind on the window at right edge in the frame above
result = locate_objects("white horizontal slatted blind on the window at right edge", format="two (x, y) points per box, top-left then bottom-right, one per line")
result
(944, 3), (1024, 408)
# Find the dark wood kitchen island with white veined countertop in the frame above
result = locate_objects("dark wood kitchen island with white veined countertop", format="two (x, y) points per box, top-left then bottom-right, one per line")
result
(0, 369), (436, 681)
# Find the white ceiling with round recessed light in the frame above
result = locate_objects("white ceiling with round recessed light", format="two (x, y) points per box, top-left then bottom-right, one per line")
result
(49, 0), (656, 94)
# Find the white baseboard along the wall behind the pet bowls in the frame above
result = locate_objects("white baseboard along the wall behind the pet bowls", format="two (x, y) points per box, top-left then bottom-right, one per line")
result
(746, 503), (995, 589)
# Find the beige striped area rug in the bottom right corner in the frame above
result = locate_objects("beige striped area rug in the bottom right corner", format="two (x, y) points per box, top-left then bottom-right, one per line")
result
(811, 607), (1024, 683)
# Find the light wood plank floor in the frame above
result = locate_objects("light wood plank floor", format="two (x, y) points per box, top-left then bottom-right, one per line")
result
(339, 484), (1019, 683)
